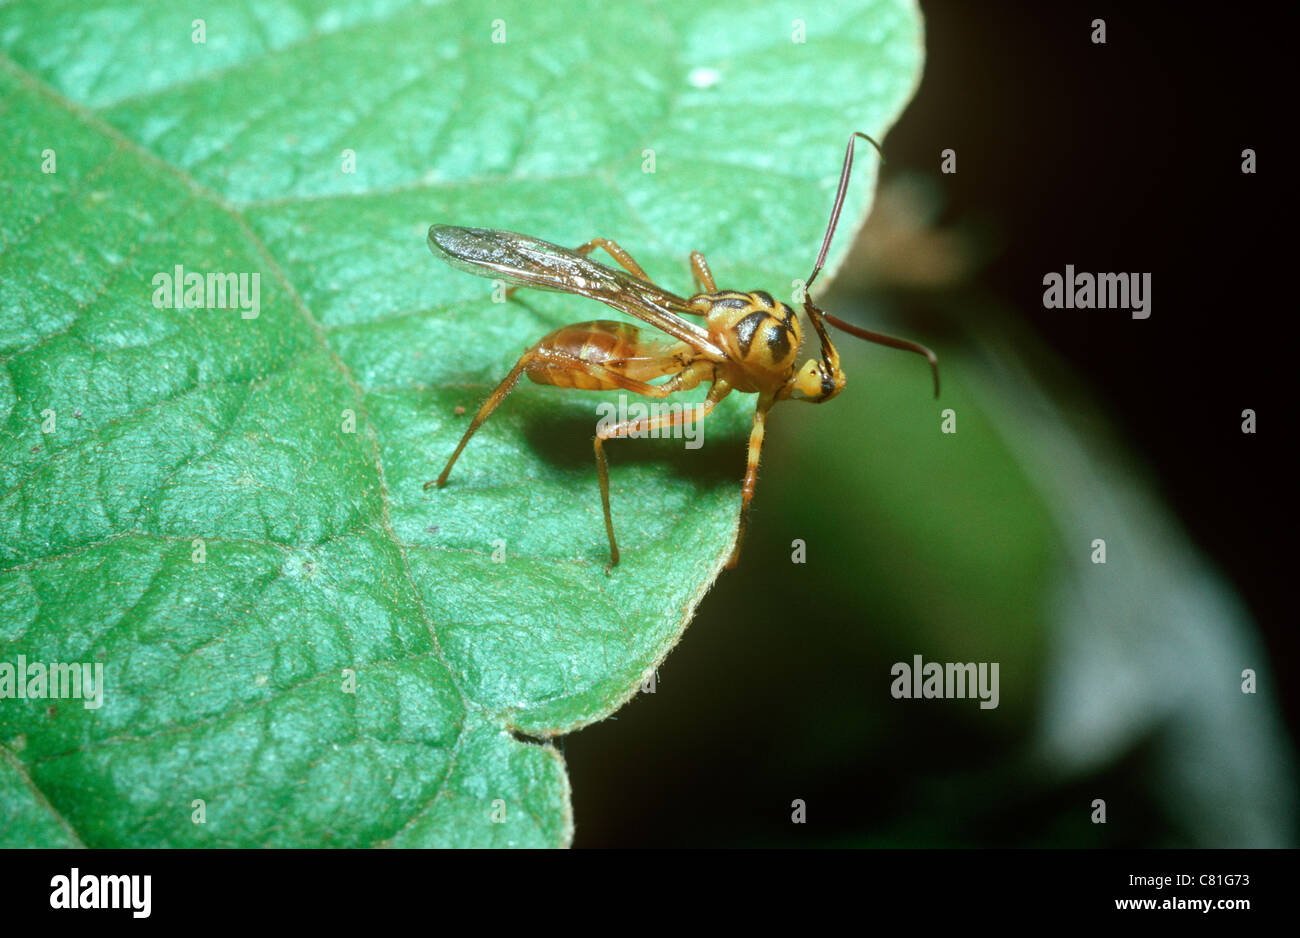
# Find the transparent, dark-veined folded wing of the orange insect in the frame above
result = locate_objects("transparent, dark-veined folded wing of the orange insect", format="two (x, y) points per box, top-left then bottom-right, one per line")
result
(429, 225), (725, 360)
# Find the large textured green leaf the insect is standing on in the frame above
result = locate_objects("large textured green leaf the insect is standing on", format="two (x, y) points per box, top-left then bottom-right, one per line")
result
(0, 0), (922, 847)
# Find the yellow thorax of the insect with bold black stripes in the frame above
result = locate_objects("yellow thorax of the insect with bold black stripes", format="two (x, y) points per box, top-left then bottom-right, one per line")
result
(693, 290), (801, 378)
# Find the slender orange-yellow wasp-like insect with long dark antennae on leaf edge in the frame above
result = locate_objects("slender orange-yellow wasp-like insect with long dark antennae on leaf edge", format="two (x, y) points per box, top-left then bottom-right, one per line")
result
(424, 131), (939, 573)
